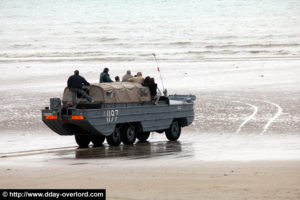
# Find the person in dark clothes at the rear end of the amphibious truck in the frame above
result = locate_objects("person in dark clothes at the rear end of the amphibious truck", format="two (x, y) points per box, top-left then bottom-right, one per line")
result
(68, 70), (94, 107)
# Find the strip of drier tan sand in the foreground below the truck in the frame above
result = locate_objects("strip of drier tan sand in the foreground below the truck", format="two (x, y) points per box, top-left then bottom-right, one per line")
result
(0, 159), (300, 200)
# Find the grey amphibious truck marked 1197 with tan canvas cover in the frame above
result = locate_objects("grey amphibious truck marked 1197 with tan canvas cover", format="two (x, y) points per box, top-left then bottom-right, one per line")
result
(42, 82), (196, 147)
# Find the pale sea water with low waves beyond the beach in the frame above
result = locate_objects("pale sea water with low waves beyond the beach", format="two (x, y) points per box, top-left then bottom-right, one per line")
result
(0, 0), (300, 64)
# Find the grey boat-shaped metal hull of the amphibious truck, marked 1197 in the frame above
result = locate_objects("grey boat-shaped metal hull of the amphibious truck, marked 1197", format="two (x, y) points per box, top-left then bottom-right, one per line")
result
(42, 101), (194, 136)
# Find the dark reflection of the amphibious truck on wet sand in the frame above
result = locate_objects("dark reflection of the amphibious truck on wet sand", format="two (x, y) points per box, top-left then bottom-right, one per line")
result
(75, 141), (189, 159)
